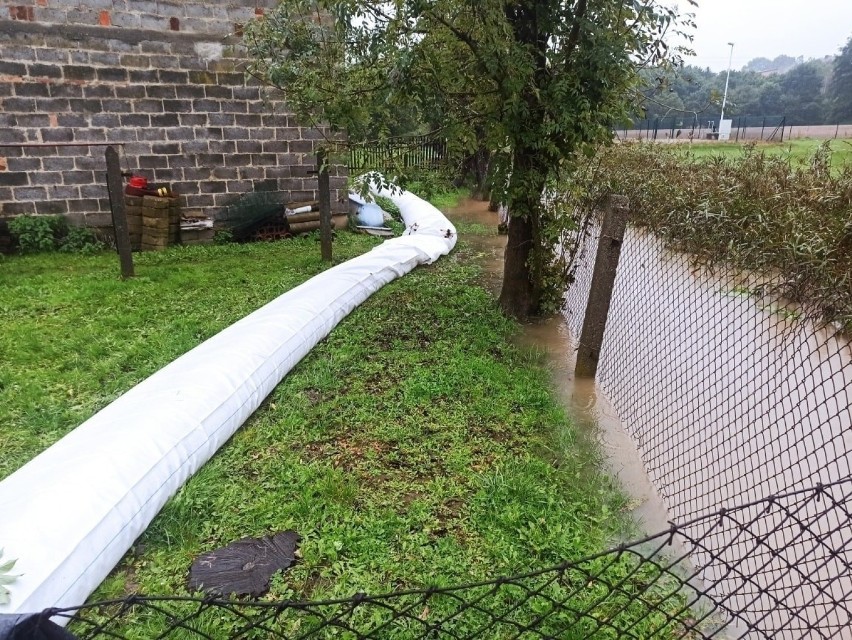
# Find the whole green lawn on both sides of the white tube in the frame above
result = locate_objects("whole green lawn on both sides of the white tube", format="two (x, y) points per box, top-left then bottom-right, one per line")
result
(0, 210), (664, 638)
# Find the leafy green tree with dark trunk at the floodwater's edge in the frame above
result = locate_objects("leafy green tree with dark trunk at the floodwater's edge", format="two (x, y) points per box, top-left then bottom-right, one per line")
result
(246, 0), (695, 317)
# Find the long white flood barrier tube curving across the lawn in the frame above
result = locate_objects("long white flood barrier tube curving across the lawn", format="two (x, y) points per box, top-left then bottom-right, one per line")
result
(0, 185), (456, 614)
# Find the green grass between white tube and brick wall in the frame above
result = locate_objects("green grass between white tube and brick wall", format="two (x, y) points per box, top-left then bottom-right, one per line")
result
(0, 233), (378, 478)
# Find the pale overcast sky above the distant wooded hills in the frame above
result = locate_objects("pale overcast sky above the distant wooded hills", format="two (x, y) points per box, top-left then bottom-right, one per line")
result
(672, 0), (852, 71)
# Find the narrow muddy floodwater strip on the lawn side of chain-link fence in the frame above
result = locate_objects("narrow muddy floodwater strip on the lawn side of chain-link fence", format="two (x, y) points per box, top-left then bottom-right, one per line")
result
(447, 200), (670, 534)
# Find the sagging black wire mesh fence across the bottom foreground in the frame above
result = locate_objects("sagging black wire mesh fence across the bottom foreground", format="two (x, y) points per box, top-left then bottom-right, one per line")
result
(13, 480), (852, 640)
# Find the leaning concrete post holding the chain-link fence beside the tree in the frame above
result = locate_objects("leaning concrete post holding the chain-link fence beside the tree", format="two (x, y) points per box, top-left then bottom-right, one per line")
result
(574, 196), (630, 378)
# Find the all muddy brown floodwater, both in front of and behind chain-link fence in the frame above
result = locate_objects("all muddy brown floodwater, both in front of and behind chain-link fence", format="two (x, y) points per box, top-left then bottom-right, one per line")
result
(448, 201), (852, 640)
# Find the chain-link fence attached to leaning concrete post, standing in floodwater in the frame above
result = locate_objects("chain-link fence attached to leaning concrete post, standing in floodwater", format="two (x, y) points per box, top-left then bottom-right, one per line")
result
(566, 209), (852, 637)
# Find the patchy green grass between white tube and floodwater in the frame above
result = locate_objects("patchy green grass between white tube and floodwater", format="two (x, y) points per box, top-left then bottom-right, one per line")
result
(85, 221), (623, 599)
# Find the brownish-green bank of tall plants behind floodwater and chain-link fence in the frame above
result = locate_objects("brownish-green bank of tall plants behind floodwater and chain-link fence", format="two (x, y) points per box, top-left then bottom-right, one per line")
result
(601, 143), (852, 330)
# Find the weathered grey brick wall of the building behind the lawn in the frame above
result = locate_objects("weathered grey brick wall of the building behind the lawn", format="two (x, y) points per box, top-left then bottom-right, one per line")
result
(0, 0), (346, 236)
